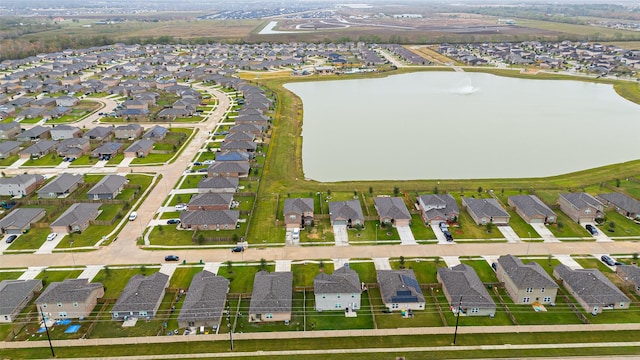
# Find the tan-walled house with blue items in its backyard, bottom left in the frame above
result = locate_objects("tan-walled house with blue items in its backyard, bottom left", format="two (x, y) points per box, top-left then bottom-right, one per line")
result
(36, 279), (104, 319)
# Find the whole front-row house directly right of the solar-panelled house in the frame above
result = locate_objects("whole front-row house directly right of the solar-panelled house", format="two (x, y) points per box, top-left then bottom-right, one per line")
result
(437, 264), (496, 316)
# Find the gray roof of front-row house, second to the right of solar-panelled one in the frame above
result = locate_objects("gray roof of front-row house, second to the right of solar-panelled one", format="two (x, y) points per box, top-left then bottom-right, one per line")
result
(498, 255), (558, 289)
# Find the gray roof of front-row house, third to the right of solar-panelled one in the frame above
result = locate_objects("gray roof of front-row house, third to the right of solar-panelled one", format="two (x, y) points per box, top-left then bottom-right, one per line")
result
(553, 264), (630, 306)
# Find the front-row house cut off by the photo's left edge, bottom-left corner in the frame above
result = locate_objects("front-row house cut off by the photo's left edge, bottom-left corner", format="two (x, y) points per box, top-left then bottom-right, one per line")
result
(0, 280), (42, 323)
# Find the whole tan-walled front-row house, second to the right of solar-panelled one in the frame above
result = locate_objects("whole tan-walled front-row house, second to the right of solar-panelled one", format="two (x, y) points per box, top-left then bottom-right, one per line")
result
(496, 255), (558, 305)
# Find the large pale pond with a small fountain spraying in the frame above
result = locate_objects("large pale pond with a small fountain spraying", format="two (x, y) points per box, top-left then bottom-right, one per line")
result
(285, 72), (640, 182)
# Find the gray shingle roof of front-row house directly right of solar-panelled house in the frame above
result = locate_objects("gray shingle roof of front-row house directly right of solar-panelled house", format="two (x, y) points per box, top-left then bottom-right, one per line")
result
(438, 264), (496, 309)
